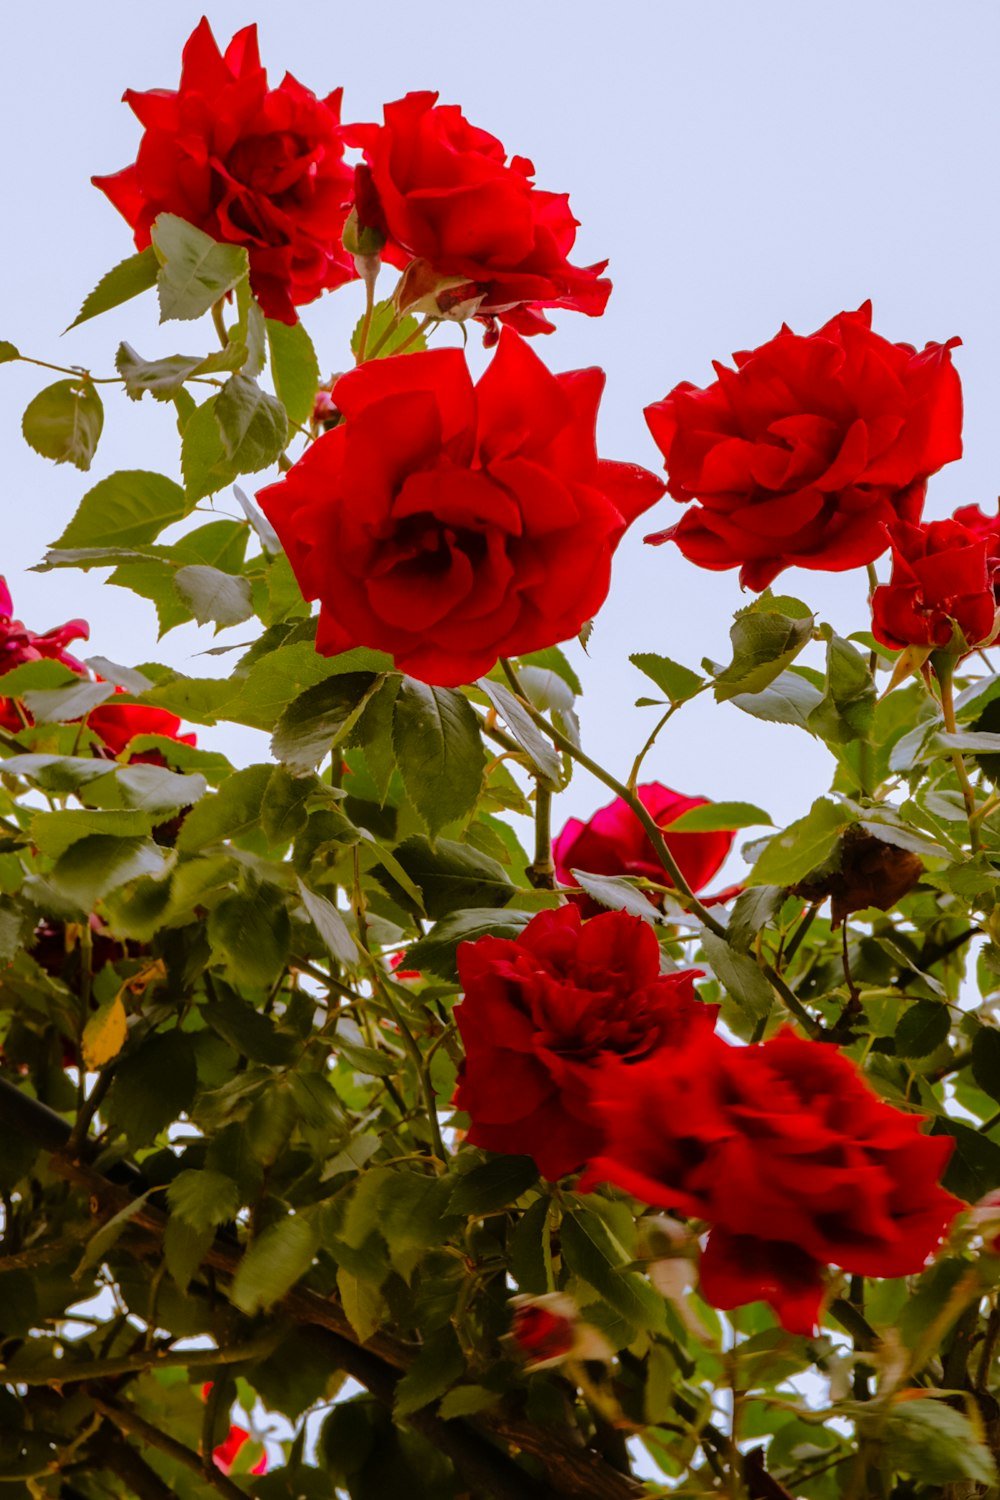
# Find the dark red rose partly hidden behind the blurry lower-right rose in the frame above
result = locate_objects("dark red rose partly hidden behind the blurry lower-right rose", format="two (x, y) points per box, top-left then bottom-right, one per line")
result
(454, 906), (717, 1181)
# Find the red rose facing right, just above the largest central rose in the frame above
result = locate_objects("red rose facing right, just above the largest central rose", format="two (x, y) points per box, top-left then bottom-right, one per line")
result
(348, 93), (612, 333)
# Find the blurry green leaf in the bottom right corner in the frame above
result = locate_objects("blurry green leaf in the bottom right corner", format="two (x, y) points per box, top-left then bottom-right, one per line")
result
(877, 1397), (997, 1490)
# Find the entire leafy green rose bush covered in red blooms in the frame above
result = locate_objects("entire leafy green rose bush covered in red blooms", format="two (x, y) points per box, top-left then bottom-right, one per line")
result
(0, 23), (1000, 1500)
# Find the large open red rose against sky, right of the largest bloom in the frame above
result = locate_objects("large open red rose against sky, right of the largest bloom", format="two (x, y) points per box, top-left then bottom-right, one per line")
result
(646, 302), (963, 590)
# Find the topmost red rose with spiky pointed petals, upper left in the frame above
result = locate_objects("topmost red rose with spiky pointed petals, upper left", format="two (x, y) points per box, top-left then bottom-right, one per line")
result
(93, 20), (355, 323)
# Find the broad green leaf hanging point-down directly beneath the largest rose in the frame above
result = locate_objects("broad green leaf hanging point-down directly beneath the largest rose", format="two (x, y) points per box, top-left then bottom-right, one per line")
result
(393, 677), (486, 837)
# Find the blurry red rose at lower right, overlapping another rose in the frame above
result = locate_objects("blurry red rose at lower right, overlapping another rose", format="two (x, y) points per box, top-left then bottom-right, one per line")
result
(580, 1029), (963, 1334)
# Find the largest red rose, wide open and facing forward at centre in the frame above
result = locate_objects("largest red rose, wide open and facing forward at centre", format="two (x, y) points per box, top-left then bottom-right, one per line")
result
(258, 330), (661, 686)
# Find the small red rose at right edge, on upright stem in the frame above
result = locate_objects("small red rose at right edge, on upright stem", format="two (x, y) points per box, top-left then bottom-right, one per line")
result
(871, 521), (997, 654)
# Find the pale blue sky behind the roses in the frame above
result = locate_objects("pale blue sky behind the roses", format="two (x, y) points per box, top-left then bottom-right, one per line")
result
(0, 0), (1000, 846)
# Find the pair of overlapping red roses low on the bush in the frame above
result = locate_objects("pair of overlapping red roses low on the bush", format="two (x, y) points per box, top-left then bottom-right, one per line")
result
(454, 906), (961, 1332)
